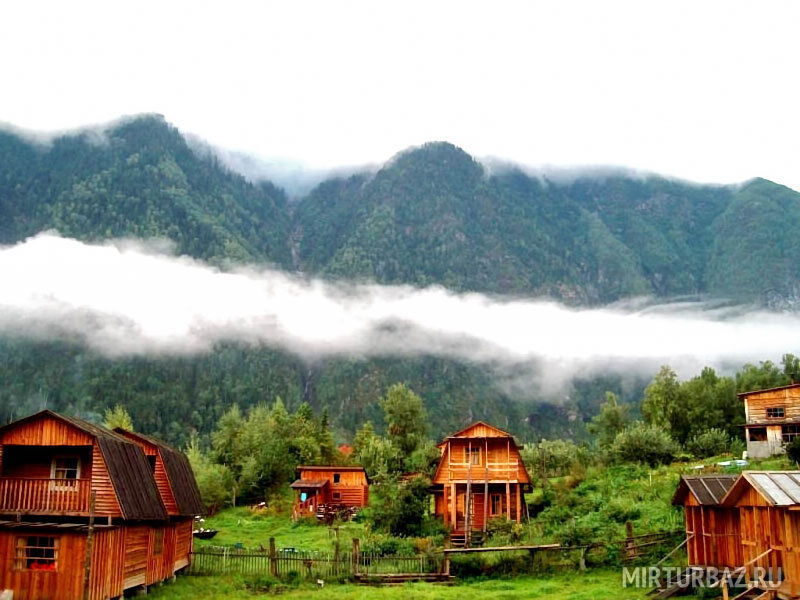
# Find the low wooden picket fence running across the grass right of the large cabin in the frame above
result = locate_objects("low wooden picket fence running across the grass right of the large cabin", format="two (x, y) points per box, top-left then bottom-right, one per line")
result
(189, 538), (444, 579)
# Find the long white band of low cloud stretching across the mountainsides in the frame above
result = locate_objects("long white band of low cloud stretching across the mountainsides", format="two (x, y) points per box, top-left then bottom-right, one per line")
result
(0, 232), (800, 389)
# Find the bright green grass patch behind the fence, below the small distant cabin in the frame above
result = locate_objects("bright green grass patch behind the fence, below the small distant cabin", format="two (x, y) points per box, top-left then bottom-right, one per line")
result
(195, 507), (366, 550)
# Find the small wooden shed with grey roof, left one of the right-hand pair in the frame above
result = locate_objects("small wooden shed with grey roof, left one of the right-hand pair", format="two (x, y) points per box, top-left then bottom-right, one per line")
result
(672, 475), (744, 569)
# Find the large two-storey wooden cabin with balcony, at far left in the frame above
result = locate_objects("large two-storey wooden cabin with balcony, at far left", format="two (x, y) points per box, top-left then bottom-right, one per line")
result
(0, 410), (199, 600)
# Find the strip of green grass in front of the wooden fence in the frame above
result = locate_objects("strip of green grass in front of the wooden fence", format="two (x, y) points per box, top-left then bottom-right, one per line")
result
(148, 569), (646, 600)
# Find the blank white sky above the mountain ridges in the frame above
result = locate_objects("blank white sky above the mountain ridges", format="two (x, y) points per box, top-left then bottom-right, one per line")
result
(0, 0), (800, 189)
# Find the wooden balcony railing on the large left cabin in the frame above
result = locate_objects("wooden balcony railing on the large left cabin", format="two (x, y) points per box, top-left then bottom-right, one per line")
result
(0, 477), (92, 514)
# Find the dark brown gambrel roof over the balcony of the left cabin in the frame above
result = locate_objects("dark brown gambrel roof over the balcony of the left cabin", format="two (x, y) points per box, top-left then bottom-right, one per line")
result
(0, 410), (167, 521)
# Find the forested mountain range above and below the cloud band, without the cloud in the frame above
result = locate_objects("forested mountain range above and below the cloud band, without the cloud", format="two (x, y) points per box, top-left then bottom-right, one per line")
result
(0, 116), (800, 444)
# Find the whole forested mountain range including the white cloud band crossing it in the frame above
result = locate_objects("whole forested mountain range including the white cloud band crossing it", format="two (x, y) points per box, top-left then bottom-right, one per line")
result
(0, 116), (800, 444)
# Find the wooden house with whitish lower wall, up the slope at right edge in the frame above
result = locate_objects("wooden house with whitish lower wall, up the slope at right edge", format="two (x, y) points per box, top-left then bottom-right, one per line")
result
(739, 383), (800, 458)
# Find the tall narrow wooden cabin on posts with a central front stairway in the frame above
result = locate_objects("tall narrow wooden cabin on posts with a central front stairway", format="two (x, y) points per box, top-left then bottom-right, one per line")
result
(432, 421), (531, 534)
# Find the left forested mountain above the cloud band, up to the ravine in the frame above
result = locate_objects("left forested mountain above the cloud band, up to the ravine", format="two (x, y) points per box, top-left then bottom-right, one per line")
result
(0, 116), (291, 267)
